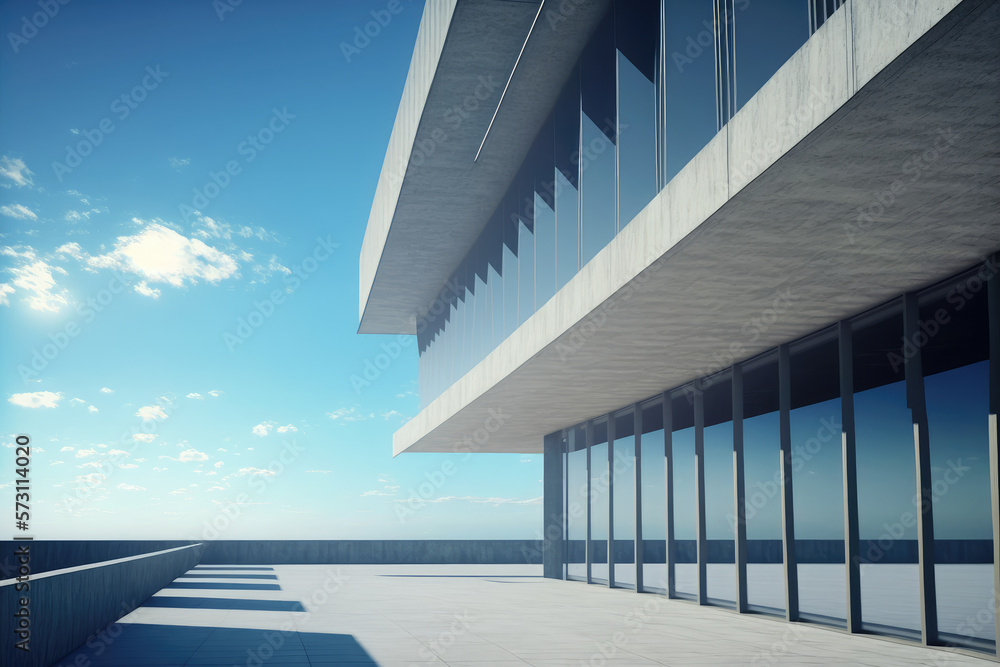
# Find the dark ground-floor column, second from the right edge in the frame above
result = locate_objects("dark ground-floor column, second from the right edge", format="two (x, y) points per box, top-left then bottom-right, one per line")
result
(903, 292), (938, 645)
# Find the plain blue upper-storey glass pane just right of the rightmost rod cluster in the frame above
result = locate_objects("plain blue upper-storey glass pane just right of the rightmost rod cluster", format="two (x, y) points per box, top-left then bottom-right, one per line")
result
(735, 0), (809, 111)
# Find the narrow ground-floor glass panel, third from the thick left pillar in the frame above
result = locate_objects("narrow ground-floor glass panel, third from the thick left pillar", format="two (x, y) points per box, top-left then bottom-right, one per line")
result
(612, 412), (635, 588)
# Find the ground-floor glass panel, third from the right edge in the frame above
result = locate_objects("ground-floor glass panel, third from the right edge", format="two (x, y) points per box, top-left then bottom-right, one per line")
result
(790, 334), (847, 624)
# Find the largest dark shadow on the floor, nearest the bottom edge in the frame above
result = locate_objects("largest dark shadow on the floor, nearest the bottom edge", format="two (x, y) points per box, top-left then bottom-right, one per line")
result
(55, 623), (378, 667)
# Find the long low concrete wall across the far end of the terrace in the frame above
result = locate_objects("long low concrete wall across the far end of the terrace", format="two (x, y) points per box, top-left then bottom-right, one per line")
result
(201, 540), (542, 565)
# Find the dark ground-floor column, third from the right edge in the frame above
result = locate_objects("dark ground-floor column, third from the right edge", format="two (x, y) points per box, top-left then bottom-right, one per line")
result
(837, 320), (861, 632)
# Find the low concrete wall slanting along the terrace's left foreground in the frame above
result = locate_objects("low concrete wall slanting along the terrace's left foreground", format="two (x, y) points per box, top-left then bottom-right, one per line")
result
(0, 543), (204, 667)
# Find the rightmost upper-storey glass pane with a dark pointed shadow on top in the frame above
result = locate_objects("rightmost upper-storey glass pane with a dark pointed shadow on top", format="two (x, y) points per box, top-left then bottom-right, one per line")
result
(615, 0), (660, 228)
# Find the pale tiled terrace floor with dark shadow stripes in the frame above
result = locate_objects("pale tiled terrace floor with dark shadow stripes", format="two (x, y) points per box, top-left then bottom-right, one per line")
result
(60, 565), (990, 667)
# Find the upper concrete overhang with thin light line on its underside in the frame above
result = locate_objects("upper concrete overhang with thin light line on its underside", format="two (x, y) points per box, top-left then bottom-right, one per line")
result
(358, 0), (609, 334)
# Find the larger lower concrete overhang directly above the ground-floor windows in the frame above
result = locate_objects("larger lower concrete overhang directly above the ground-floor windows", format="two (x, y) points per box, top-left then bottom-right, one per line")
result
(393, 0), (1000, 454)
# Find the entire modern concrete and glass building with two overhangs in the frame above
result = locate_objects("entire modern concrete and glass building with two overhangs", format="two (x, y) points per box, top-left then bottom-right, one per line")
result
(360, 0), (1000, 655)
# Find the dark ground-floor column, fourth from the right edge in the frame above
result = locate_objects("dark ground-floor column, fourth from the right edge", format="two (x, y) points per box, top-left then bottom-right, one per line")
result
(778, 345), (799, 621)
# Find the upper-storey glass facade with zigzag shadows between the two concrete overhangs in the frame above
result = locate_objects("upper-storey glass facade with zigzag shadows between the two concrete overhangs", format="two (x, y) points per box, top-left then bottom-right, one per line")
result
(417, 0), (840, 405)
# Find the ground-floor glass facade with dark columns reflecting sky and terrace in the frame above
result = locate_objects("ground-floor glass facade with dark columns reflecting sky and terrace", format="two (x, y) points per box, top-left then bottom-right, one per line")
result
(563, 257), (1000, 653)
